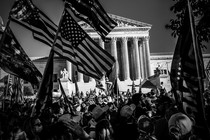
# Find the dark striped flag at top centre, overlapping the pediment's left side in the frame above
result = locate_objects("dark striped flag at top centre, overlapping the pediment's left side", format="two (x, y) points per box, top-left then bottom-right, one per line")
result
(65, 0), (117, 41)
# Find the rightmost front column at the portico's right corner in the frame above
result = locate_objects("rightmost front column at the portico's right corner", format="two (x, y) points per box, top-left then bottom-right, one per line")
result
(144, 36), (152, 76)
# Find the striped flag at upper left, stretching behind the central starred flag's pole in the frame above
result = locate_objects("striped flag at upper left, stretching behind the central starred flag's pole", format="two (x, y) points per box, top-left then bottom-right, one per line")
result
(10, 0), (77, 65)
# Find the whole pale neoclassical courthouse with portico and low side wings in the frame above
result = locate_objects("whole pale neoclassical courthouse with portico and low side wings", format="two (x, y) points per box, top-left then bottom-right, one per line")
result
(0, 14), (210, 93)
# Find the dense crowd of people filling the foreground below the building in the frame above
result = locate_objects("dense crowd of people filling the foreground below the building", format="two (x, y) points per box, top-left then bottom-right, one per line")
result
(0, 84), (210, 140)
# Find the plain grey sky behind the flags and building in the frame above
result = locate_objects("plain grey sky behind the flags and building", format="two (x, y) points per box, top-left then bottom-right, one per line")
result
(0, 0), (210, 57)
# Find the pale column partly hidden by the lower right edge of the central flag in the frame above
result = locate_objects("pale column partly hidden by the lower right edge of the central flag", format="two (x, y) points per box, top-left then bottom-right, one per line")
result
(111, 38), (118, 80)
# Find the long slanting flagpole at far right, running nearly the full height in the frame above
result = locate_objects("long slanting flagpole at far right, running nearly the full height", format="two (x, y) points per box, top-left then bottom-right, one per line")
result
(187, 0), (210, 137)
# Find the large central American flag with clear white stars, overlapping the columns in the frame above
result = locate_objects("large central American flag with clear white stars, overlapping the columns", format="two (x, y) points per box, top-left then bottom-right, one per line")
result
(58, 9), (115, 79)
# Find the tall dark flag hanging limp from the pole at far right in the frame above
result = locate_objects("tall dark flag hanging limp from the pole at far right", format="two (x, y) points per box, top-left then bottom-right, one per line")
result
(170, 1), (205, 129)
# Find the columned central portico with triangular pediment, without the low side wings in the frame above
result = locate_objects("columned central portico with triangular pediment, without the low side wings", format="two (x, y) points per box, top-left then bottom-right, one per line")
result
(67, 14), (152, 82)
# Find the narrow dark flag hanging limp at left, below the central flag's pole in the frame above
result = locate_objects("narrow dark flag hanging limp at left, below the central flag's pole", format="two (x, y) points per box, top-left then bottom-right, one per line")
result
(31, 50), (54, 116)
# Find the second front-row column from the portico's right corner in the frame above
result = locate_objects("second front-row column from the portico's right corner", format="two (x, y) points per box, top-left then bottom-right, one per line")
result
(133, 37), (141, 79)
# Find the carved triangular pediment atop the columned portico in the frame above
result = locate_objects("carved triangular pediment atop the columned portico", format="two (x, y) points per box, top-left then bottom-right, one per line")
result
(78, 14), (152, 29)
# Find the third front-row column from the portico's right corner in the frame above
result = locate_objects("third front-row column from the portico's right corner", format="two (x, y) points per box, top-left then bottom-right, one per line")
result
(122, 37), (130, 80)
